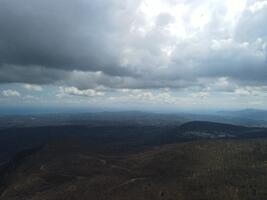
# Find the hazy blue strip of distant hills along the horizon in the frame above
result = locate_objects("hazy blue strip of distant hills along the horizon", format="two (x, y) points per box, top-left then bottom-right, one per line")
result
(0, 109), (267, 129)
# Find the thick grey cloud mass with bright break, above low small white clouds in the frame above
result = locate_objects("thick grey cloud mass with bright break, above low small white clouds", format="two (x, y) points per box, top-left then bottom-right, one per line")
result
(0, 0), (267, 89)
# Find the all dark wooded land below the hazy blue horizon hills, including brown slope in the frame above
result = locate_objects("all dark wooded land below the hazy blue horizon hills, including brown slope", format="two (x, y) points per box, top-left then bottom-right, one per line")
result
(0, 119), (267, 200)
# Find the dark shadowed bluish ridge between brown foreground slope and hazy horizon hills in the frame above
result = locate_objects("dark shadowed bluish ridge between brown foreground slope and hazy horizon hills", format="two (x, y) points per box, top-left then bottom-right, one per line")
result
(0, 120), (267, 166)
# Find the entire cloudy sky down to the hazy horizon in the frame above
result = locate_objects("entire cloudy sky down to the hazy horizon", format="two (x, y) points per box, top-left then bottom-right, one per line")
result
(0, 0), (267, 110)
